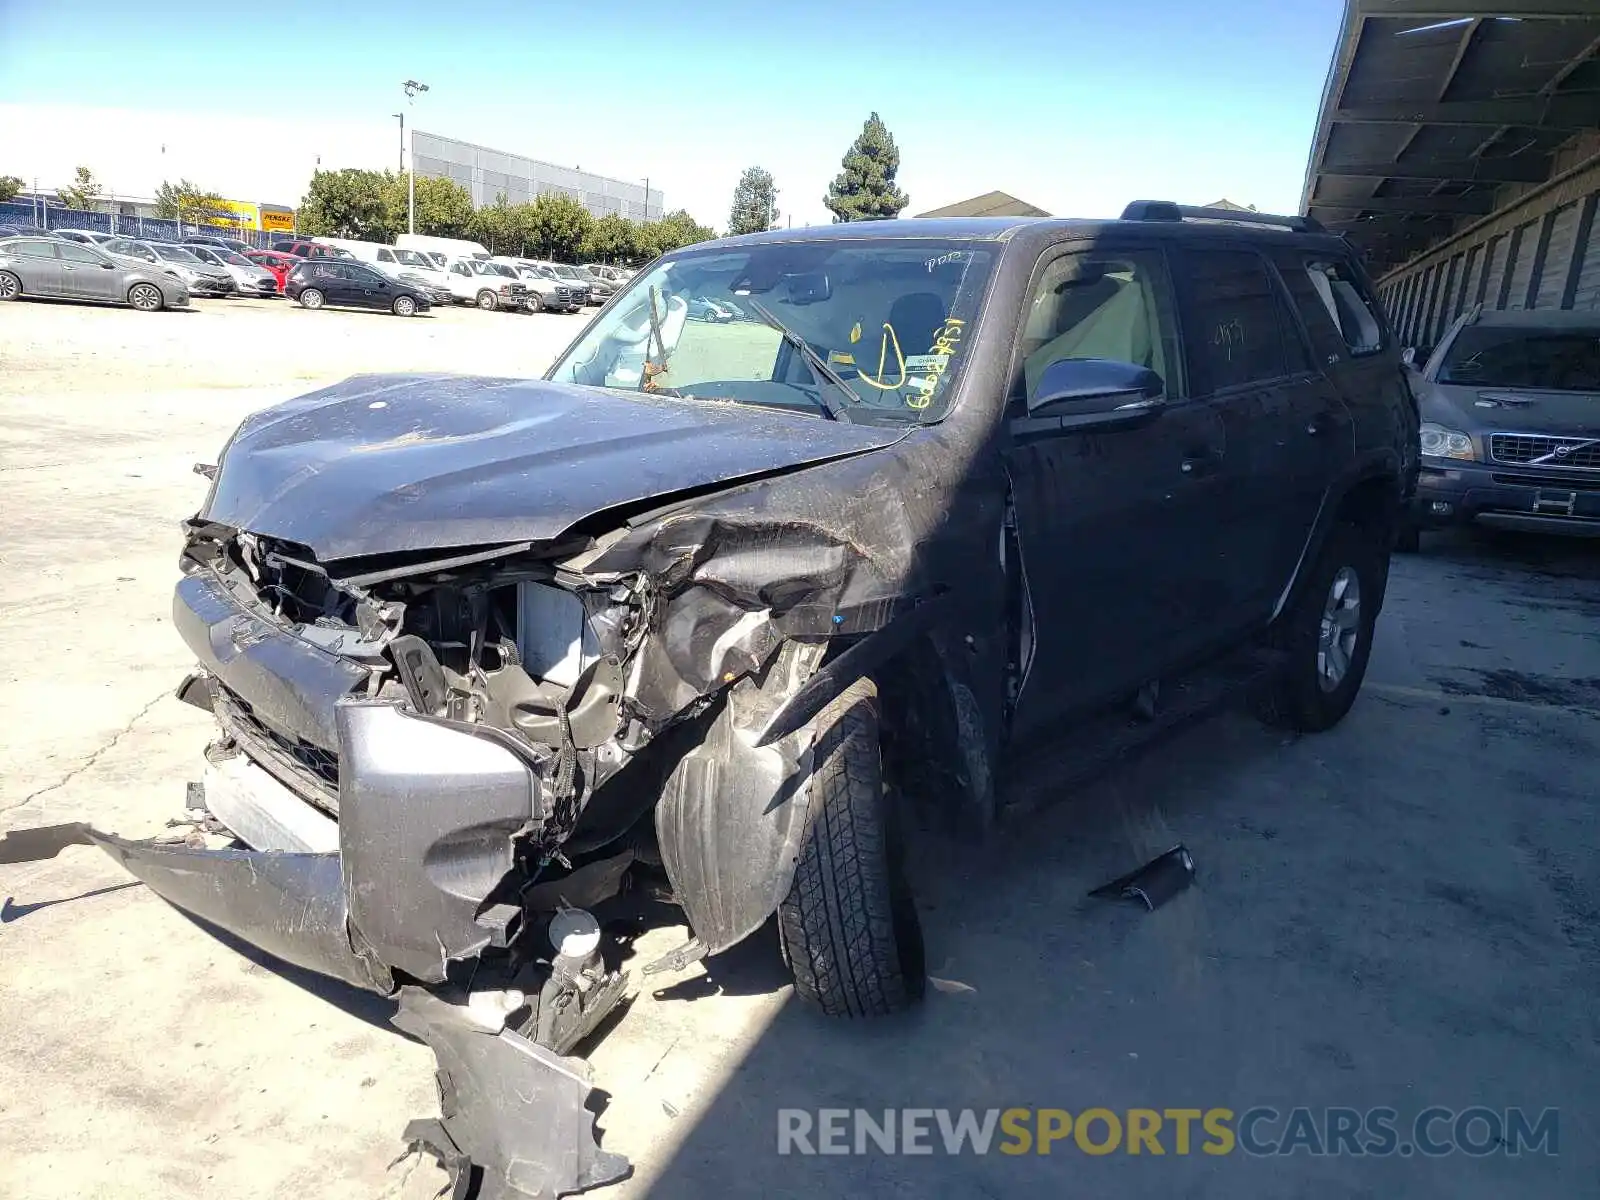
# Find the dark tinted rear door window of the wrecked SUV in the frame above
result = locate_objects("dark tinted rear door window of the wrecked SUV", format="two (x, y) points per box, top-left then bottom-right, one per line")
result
(1178, 250), (1307, 395)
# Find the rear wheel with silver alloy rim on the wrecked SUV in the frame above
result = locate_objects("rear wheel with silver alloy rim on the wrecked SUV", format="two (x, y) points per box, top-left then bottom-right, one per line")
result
(1264, 525), (1389, 733)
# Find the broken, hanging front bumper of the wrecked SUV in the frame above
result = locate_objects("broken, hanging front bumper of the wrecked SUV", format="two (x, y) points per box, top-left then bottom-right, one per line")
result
(94, 571), (556, 992)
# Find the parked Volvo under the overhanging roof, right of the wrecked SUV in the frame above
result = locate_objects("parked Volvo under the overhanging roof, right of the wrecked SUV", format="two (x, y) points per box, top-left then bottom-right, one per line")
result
(1400, 307), (1600, 550)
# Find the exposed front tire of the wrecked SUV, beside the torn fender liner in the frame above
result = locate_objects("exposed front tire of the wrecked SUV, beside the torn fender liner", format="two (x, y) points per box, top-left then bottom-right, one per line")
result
(778, 680), (926, 1016)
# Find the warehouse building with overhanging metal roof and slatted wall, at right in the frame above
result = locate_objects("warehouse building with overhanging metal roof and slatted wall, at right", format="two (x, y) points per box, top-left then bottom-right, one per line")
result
(1301, 0), (1600, 347)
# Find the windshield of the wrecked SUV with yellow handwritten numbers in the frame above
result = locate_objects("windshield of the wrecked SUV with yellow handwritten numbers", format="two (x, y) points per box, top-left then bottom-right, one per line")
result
(549, 238), (995, 422)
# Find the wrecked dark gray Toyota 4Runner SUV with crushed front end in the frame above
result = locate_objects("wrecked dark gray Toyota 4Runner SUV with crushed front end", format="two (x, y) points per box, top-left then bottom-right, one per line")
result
(94, 202), (1419, 1195)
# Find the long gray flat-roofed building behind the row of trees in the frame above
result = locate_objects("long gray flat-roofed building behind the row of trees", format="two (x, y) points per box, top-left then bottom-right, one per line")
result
(411, 130), (664, 221)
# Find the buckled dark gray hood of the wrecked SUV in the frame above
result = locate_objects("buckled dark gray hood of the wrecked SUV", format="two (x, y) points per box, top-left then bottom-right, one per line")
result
(200, 374), (906, 562)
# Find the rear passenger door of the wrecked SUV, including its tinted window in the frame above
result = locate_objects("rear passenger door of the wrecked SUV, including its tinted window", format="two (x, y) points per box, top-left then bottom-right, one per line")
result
(1174, 245), (1349, 620)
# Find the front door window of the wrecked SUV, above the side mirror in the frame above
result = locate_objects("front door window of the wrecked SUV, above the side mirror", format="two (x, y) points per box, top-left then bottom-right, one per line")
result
(1011, 250), (1184, 400)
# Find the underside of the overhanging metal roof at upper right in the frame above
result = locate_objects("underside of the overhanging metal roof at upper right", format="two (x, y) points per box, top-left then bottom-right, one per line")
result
(1301, 0), (1600, 272)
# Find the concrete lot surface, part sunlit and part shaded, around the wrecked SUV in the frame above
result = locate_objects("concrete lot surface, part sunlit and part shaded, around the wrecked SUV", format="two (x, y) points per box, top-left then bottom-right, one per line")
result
(0, 301), (1600, 1200)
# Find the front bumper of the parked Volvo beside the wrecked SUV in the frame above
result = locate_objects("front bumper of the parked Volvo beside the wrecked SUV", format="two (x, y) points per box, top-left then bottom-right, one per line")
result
(1411, 458), (1600, 538)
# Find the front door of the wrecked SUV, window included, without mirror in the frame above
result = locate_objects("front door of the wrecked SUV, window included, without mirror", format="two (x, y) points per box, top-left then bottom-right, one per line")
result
(1006, 238), (1229, 741)
